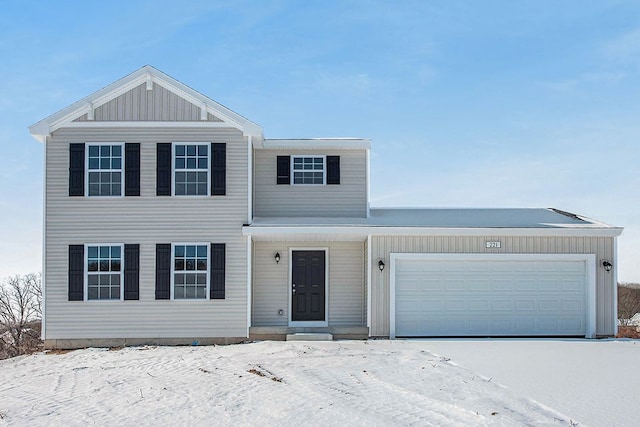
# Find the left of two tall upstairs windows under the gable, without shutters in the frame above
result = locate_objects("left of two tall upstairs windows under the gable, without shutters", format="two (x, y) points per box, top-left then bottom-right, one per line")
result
(87, 144), (124, 196)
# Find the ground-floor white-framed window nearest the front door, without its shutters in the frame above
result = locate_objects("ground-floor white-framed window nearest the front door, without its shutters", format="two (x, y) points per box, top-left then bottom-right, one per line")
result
(173, 244), (209, 299)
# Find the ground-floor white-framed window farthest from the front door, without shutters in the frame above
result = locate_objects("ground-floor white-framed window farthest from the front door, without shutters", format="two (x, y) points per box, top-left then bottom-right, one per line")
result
(86, 245), (124, 300)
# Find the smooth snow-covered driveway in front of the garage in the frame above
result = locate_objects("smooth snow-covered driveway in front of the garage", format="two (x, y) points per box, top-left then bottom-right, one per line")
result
(420, 339), (640, 427)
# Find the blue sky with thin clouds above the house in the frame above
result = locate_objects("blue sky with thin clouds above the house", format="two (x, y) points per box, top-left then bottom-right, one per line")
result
(0, 0), (640, 282)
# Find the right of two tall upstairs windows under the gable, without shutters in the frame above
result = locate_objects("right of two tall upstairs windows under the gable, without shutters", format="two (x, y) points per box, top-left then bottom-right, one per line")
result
(174, 144), (210, 196)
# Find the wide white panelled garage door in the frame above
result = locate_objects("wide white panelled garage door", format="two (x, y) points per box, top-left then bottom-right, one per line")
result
(391, 255), (591, 337)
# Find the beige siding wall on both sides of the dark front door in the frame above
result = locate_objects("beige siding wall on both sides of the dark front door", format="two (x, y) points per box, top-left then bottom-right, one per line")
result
(251, 242), (366, 326)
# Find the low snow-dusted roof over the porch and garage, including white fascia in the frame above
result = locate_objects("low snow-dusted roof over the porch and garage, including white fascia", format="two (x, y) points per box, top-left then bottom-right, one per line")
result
(242, 208), (622, 241)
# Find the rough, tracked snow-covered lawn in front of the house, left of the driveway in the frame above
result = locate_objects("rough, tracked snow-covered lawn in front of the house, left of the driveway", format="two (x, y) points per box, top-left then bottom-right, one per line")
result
(0, 341), (576, 426)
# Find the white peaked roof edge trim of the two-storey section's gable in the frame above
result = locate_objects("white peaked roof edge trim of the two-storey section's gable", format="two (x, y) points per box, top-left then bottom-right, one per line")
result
(29, 65), (263, 142)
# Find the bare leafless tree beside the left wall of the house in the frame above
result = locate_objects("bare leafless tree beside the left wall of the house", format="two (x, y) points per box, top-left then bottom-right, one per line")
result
(0, 273), (42, 359)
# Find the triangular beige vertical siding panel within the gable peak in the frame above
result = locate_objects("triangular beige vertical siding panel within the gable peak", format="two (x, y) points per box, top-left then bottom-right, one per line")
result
(74, 83), (222, 122)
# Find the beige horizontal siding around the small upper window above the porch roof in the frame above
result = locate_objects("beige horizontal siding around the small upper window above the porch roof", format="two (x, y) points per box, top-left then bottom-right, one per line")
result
(253, 149), (367, 217)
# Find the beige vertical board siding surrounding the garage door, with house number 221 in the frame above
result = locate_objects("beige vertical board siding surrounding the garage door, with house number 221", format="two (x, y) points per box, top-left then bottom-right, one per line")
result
(370, 235), (616, 337)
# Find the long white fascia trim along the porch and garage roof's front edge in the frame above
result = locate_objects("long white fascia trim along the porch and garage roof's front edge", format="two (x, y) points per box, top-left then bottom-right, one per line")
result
(242, 225), (623, 239)
